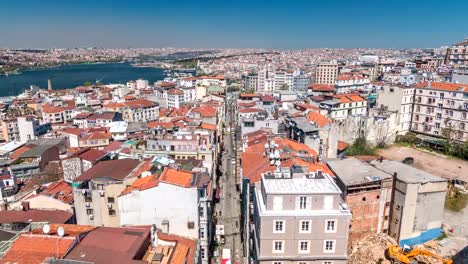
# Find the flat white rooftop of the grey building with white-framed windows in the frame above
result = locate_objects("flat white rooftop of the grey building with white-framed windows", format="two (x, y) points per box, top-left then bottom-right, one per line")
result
(262, 176), (341, 194)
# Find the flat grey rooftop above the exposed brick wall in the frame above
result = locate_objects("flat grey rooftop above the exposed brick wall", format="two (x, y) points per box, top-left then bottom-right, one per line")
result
(327, 158), (393, 186)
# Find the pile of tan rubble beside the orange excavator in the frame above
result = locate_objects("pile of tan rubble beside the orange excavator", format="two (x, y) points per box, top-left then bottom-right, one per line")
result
(348, 233), (396, 264)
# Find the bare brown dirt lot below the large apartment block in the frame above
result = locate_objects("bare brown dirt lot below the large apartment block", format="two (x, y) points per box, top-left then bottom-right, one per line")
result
(379, 145), (468, 182)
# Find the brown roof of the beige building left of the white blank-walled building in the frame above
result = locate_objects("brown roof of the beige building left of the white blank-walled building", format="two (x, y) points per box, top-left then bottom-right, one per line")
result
(75, 159), (141, 182)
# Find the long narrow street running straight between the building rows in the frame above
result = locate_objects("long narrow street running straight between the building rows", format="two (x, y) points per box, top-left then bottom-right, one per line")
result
(217, 96), (243, 263)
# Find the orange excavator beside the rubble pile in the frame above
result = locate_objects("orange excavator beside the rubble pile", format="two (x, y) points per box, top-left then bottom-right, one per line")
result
(387, 245), (453, 264)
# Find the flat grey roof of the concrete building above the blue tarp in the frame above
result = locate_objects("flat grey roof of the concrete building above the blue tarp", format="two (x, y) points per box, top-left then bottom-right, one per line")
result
(370, 160), (447, 183)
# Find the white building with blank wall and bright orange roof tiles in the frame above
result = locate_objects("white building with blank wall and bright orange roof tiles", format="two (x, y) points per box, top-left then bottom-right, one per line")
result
(118, 167), (213, 264)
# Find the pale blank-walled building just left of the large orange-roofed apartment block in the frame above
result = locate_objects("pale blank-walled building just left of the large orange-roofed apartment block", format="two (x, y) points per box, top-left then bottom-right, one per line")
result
(377, 85), (415, 135)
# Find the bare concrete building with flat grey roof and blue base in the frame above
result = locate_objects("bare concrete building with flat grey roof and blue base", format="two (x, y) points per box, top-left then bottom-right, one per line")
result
(370, 160), (448, 246)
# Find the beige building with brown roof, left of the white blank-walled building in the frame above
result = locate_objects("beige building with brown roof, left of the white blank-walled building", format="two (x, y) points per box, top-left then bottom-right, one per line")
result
(73, 159), (151, 226)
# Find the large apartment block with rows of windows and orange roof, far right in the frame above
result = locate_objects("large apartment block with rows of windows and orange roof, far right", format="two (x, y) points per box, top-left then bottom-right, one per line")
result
(411, 82), (468, 141)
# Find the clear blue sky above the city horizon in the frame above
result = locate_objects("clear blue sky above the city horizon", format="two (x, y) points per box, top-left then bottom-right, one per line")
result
(0, 0), (468, 49)
